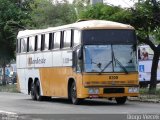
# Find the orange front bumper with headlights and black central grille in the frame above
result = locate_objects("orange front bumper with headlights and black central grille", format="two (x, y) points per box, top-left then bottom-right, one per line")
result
(78, 87), (139, 98)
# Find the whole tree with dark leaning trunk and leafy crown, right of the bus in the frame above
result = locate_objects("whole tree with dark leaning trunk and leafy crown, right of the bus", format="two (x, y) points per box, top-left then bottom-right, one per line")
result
(131, 0), (160, 93)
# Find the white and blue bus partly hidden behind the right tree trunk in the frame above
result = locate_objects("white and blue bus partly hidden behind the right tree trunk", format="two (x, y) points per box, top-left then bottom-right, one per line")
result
(138, 45), (160, 87)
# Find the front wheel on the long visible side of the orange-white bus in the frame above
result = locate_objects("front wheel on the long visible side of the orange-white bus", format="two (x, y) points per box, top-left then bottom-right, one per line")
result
(70, 82), (81, 105)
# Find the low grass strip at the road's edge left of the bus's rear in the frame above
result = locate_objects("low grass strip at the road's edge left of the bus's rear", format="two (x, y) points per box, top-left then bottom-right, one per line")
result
(0, 84), (18, 93)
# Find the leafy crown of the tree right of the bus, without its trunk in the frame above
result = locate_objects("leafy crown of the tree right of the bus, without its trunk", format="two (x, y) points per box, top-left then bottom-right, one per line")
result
(131, 0), (160, 41)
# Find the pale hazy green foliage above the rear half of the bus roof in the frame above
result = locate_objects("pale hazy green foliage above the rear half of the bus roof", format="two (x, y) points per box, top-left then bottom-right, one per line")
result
(30, 0), (76, 28)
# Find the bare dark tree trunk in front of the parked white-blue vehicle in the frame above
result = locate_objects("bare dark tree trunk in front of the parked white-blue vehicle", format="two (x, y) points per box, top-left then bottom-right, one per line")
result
(149, 51), (159, 93)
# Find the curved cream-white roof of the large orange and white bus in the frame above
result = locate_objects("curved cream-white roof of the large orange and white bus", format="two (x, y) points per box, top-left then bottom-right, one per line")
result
(17, 20), (134, 38)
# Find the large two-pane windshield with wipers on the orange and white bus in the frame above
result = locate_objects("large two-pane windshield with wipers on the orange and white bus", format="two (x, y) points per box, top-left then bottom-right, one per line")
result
(84, 45), (137, 73)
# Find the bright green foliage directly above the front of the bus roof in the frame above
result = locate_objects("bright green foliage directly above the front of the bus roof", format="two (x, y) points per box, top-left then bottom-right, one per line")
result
(80, 3), (131, 23)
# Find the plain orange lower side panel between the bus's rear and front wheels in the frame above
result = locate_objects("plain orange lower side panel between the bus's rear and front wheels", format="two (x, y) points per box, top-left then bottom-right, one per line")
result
(39, 67), (72, 98)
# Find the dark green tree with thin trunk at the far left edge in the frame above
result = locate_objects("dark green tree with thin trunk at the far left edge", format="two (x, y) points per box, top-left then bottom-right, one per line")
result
(0, 0), (28, 84)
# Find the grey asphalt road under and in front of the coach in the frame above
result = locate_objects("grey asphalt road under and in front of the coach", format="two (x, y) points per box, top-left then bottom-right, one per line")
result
(0, 92), (160, 120)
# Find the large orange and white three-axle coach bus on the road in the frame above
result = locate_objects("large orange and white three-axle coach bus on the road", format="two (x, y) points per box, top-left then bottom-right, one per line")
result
(16, 20), (139, 104)
